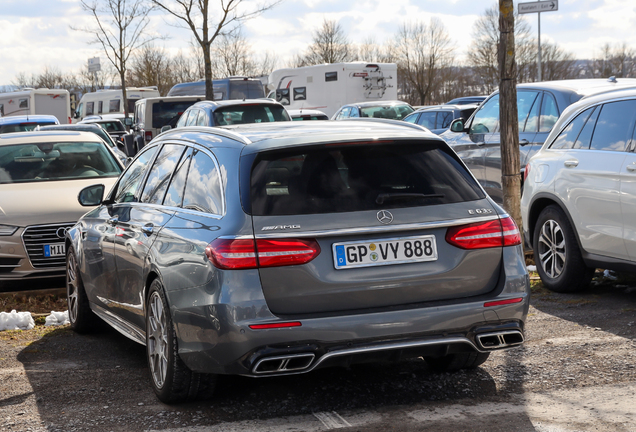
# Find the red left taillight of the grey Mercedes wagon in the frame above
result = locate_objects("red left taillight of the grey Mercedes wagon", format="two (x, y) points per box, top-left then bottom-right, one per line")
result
(205, 239), (320, 270)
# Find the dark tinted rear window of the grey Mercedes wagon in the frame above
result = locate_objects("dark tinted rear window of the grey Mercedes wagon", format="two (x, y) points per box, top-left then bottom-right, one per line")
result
(243, 141), (484, 216)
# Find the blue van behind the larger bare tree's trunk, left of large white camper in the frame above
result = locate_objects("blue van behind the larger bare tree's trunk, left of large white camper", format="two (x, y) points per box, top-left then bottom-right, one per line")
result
(168, 77), (265, 100)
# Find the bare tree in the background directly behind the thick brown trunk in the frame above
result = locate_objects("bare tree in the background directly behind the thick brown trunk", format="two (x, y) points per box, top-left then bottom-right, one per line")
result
(467, 4), (536, 93)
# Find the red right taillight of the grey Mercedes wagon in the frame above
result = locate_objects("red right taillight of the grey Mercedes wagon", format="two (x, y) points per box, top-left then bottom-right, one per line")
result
(446, 217), (521, 249)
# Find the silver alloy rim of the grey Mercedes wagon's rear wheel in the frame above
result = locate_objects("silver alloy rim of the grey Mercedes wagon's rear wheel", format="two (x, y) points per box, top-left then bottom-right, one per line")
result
(148, 291), (168, 388)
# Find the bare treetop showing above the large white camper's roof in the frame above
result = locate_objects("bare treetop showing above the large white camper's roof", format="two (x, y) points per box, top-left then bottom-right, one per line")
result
(299, 19), (355, 66)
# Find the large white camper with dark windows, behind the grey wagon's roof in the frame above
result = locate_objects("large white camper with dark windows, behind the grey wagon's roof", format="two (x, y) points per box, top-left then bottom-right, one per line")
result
(268, 62), (398, 117)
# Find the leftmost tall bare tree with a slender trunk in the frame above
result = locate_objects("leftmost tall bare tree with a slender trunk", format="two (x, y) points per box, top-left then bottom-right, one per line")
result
(71, 0), (160, 117)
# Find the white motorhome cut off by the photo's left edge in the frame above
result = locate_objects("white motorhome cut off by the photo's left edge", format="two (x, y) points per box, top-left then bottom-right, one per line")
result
(0, 88), (71, 124)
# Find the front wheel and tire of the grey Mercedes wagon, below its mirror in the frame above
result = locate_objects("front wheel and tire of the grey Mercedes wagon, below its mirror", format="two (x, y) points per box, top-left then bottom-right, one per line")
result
(66, 246), (99, 334)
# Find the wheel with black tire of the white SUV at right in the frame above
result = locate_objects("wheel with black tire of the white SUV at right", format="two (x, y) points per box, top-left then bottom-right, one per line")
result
(532, 205), (594, 293)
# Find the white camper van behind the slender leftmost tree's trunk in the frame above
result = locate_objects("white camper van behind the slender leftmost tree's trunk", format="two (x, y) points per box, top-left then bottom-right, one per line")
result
(74, 86), (159, 122)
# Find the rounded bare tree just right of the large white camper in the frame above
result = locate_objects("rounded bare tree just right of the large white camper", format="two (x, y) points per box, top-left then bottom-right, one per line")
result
(395, 18), (454, 105)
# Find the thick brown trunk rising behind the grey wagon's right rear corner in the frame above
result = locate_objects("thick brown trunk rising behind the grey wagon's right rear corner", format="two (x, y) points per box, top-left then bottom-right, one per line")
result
(499, 0), (522, 233)
